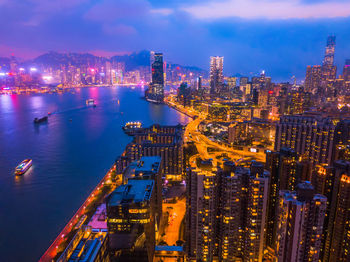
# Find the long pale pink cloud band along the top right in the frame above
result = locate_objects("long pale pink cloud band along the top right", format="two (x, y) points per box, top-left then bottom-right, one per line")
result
(182, 0), (350, 19)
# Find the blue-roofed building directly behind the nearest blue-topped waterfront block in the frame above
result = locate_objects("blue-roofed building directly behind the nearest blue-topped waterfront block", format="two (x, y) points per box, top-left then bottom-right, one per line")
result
(123, 156), (163, 226)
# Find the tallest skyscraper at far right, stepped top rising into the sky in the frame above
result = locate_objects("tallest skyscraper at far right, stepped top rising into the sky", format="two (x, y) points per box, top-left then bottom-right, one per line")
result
(322, 36), (337, 81)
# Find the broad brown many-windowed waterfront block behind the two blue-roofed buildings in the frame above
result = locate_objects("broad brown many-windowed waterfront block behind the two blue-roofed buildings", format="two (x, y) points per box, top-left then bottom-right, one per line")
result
(116, 125), (184, 180)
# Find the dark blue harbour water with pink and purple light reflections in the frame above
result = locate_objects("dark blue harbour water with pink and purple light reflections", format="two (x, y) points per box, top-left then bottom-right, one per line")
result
(0, 87), (188, 262)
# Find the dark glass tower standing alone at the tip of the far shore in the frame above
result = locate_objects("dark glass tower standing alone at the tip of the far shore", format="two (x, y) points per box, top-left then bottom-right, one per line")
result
(145, 53), (164, 103)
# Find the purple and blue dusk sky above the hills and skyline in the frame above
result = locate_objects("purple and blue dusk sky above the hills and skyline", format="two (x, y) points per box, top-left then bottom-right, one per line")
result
(0, 0), (350, 80)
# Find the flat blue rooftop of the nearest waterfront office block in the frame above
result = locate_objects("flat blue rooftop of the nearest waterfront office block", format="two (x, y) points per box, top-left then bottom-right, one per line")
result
(108, 180), (154, 206)
